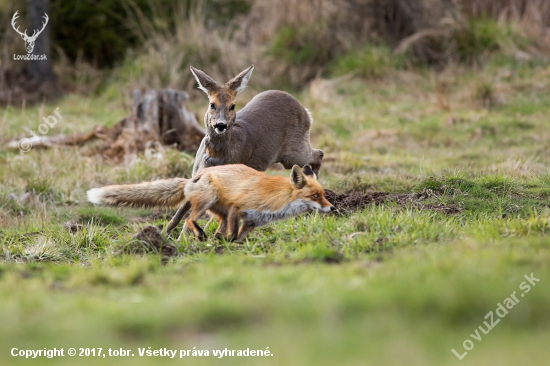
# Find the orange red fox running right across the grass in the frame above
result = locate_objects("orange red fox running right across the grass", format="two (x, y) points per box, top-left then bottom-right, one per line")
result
(87, 164), (334, 241)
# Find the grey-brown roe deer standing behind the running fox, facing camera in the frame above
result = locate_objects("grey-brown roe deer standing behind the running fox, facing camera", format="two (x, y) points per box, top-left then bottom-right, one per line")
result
(191, 65), (324, 176)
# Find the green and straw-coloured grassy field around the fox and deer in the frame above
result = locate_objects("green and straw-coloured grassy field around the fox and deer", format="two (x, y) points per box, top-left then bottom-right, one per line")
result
(0, 58), (550, 365)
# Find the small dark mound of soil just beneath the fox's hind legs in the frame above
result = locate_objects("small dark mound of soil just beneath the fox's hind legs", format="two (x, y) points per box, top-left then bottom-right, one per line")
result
(122, 226), (178, 259)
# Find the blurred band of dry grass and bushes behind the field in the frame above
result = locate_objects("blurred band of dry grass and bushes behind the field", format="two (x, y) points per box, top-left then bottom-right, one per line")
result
(0, 0), (550, 100)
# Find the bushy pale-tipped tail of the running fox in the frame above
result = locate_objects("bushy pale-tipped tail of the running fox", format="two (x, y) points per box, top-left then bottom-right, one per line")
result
(86, 178), (187, 207)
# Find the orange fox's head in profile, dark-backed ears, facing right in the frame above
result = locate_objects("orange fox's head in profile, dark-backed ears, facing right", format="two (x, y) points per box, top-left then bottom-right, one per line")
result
(290, 165), (336, 212)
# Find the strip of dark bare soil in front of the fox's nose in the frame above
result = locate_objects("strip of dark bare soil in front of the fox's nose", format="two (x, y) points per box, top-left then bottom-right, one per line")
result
(325, 189), (462, 216)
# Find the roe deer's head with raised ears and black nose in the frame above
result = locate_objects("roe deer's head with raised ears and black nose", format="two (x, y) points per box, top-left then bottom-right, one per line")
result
(191, 65), (254, 136)
